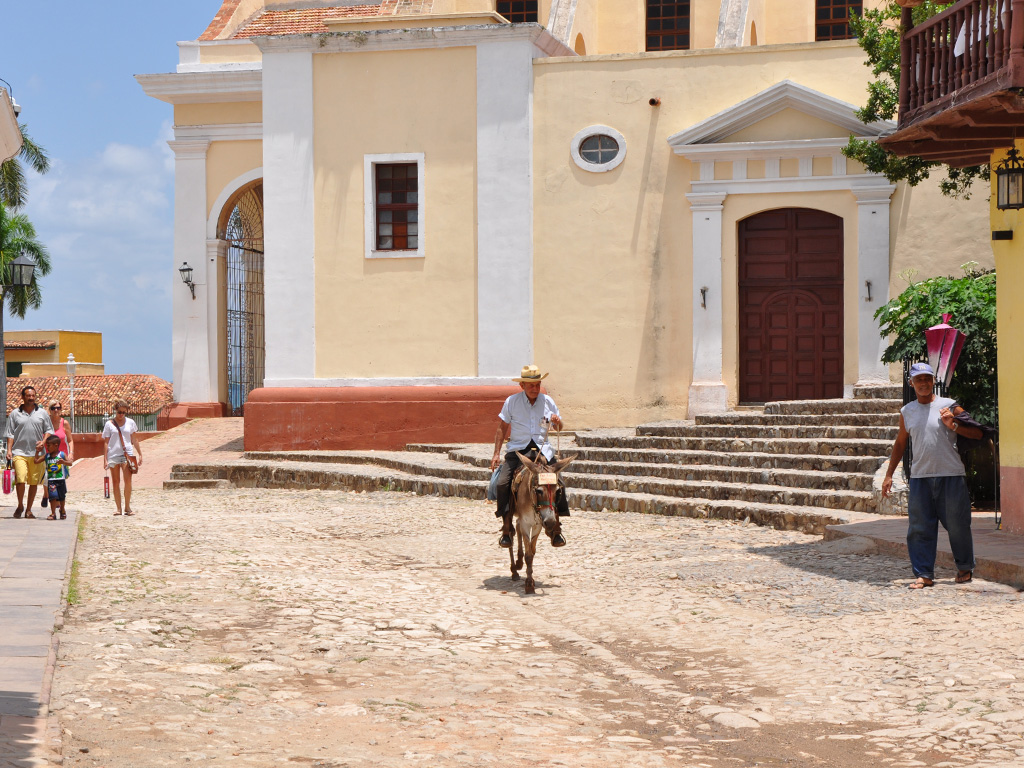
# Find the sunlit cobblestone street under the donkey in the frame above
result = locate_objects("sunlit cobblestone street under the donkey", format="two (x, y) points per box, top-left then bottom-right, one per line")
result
(50, 489), (1024, 768)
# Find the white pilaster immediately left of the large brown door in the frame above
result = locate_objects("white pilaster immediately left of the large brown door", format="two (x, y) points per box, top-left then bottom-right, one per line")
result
(686, 193), (728, 417)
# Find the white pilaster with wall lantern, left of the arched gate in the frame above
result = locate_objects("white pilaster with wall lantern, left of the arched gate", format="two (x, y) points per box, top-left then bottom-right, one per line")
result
(167, 139), (211, 403)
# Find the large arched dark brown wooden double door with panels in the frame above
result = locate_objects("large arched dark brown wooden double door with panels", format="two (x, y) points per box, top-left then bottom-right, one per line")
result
(739, 208), (844, 402)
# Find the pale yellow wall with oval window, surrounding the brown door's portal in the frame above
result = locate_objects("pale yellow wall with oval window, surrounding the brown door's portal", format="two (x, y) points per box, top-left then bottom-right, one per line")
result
(534, 42), (987, 425)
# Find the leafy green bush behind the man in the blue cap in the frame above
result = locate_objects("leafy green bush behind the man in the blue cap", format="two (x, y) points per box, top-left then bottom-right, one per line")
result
(874, 262), (998, 426)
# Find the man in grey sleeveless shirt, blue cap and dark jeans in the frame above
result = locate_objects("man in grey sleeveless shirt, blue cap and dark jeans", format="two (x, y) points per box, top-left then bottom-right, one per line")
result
(882, 362), (982, 589)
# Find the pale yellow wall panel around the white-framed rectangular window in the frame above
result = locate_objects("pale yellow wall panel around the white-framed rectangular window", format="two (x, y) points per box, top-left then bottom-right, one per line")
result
(313, 48), (476, 378)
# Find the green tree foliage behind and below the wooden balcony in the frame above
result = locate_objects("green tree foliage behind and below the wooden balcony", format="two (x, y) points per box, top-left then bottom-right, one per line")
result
(843, 0), (989, 200)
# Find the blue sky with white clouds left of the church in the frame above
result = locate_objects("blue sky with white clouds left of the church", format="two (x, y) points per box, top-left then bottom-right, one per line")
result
(0, 0), (220, 380)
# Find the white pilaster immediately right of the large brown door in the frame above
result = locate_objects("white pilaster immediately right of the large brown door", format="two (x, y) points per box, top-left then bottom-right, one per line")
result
(853, 184), (896, 384)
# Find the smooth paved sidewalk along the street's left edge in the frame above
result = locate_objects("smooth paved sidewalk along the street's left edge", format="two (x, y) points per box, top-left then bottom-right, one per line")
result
(0, 507), (78, 768)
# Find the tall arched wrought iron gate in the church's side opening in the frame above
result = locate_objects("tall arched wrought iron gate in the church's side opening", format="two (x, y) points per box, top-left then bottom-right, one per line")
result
(224, 183), (266, 416)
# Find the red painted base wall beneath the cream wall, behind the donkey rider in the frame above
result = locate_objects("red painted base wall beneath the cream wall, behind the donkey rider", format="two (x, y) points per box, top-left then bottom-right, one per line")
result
(245, 384), (519, 451)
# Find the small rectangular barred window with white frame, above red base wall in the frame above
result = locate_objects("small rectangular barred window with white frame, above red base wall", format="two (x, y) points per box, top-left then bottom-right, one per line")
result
(365, 155), (423, 258)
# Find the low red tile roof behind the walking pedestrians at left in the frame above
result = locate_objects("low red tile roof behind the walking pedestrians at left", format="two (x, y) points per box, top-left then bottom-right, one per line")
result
(7, 374), (174, 416)
